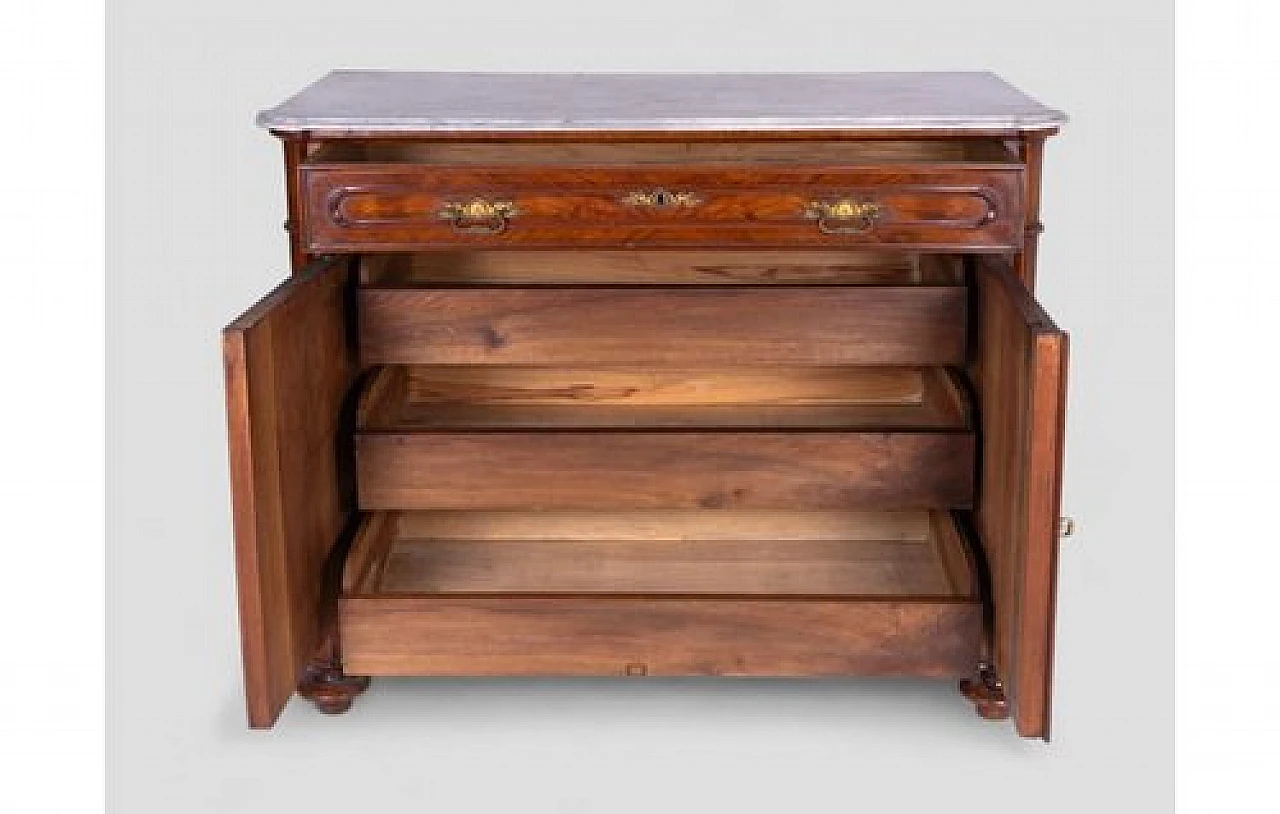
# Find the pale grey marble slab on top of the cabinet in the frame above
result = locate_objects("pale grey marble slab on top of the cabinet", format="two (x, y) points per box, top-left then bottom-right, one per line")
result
(257, 70), (1066, 133)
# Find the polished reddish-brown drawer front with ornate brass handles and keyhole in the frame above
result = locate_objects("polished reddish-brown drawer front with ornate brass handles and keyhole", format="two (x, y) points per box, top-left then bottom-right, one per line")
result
(302, 164), (1023, 251)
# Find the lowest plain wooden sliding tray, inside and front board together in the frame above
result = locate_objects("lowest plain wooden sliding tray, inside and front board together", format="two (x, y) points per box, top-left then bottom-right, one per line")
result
(339, 511), (982, 677)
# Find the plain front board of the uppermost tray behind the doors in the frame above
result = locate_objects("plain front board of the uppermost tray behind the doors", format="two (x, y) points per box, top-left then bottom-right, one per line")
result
(360, 287), (965, 365)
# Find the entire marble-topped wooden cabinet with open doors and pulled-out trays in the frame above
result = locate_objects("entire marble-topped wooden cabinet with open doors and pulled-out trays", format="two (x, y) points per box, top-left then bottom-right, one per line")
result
(224, 72), (1066, 737)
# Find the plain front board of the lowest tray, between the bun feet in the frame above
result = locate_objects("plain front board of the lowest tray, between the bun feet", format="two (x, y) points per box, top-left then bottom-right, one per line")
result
(342, 595), (982, 677)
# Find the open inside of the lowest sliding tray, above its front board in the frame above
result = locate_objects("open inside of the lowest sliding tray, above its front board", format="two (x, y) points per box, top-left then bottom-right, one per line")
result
(344, 509), (973, 596)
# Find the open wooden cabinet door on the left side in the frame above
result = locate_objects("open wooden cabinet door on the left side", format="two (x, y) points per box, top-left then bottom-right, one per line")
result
(223, 260), (357, 727)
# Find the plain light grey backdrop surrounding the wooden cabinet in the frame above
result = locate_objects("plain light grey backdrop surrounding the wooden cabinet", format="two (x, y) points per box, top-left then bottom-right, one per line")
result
(107, 0), (1172, 814)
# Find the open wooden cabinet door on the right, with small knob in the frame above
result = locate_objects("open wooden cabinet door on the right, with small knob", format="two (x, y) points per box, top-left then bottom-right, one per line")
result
(972, 259), (1068, 740)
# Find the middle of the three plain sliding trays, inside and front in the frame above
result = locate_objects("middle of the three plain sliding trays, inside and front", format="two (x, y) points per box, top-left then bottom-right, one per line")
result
(356, 366), (974, 509)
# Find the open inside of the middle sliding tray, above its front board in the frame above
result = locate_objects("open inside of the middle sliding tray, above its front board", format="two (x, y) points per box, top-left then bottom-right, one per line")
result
(357, 366), (970, 431)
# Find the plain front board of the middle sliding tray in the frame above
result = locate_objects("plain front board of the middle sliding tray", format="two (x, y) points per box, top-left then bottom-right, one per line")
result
(356, 431), (974, 509)
